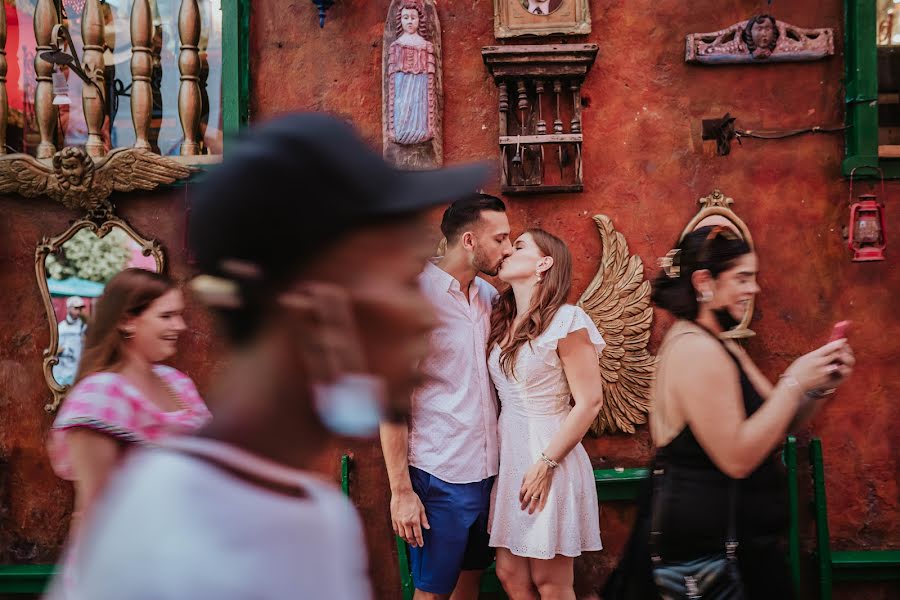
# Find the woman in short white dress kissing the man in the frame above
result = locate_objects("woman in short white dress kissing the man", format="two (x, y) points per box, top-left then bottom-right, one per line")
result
(488, 229), (605, 600)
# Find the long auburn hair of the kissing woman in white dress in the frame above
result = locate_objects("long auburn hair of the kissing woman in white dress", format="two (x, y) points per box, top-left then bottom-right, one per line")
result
(488, 229), (572, 376)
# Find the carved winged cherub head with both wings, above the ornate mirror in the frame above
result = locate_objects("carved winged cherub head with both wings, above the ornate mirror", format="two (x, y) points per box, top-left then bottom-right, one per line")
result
(0, 146), (196, 211)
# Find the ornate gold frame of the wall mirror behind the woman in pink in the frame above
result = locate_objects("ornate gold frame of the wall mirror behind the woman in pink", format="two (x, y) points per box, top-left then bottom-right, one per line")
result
(34, 215), (165, 412)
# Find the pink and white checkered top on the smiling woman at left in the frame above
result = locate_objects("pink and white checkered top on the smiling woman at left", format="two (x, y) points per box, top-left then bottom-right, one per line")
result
(47, 365), (212, 480)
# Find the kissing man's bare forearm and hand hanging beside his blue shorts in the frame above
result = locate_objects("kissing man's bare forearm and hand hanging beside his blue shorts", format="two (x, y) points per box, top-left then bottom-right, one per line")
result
(380, 422), (430, 547)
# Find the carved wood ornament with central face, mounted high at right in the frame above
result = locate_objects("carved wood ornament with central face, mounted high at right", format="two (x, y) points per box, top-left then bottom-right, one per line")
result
(684, 15), (834, 64)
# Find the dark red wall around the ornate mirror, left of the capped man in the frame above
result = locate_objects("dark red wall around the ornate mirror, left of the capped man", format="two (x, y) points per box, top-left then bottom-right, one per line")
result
(0, 187), (224, 564)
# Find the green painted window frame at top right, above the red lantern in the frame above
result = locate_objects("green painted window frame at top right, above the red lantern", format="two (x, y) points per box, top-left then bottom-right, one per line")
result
(841, 0), (900, 179)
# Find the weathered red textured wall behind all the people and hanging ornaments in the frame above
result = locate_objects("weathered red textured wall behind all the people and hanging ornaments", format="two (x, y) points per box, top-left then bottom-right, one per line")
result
(0, 0), (900, 599)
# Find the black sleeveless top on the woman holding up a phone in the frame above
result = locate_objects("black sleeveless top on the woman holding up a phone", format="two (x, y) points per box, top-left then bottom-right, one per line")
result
(656, 330), (788, 559)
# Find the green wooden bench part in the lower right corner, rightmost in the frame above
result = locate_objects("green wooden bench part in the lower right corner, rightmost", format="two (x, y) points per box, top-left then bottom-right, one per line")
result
(809, 438), (900, 600)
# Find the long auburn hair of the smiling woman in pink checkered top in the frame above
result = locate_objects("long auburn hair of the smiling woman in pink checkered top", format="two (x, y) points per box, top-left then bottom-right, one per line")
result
(75, 269), (175, 383)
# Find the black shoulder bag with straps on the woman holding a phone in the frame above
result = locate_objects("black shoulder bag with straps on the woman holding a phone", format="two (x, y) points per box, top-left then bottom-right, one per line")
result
(650, 465), (746, 600)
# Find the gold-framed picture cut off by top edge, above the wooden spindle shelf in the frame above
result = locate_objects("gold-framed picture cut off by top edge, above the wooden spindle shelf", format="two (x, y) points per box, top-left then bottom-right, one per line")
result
(494, 0), (591, 38)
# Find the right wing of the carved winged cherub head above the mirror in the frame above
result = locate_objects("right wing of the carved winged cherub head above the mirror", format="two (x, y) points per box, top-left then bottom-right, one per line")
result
(92, 148), (196, 200)
